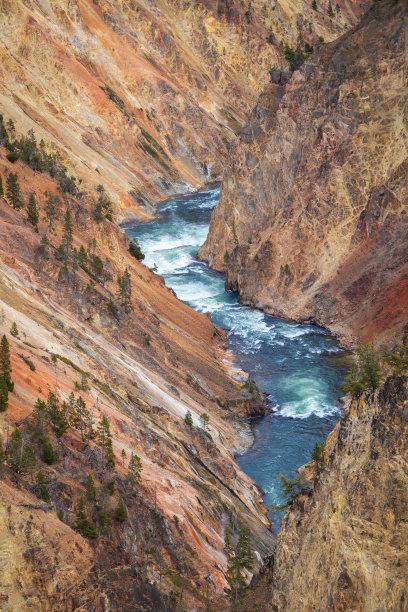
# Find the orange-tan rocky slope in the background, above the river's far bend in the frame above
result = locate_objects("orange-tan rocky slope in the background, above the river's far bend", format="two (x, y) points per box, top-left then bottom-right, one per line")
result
(0, 0), (364, 219)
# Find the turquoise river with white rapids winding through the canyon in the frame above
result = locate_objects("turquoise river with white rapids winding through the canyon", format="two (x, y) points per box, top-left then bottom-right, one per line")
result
(128, 189), (344, 524)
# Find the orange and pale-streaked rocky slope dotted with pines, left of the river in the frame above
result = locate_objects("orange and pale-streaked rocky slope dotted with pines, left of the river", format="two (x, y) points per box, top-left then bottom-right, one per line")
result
(0, 141), (273, 612)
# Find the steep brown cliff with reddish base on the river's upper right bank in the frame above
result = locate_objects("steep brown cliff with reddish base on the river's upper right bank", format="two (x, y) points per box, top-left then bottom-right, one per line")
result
(200, 1), (408, 340)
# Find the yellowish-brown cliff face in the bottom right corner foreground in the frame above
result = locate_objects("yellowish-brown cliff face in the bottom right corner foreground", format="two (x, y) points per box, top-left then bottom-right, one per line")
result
(242, 379), (408, 612)
